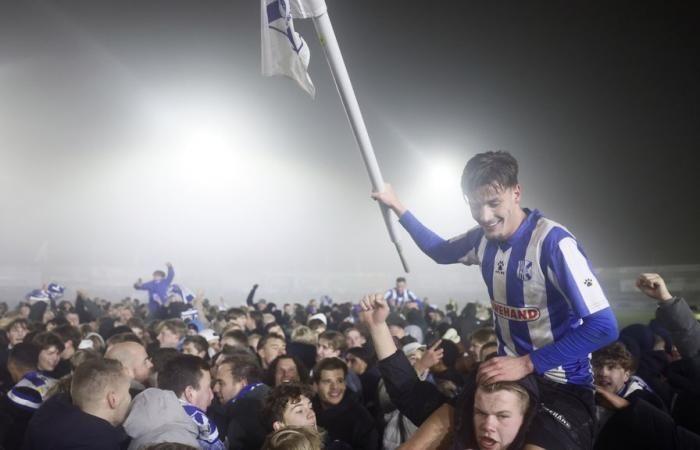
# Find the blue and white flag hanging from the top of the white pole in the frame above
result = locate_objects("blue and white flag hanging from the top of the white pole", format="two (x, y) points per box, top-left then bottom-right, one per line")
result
(260, 0), (326, 98)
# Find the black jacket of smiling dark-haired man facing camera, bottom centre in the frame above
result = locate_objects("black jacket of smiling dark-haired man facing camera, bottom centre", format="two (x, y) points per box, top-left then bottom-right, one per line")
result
(313, 389), (379, 450)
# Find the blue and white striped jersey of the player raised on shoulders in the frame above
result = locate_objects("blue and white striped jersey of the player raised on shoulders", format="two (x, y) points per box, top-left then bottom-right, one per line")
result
(401, 210), (616, 386)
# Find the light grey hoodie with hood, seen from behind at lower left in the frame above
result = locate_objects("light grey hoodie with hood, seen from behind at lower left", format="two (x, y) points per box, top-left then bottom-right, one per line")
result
(124, 388), (199, 450)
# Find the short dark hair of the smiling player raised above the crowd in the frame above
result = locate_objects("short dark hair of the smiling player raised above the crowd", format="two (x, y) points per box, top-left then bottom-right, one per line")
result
(462, 150), (518, 194)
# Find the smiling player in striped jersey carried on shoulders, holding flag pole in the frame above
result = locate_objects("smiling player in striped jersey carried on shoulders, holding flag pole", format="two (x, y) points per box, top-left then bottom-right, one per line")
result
(372, 151), (617, 449)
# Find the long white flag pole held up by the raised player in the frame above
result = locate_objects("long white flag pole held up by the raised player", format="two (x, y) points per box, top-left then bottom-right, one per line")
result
(313, 11), (409, 273)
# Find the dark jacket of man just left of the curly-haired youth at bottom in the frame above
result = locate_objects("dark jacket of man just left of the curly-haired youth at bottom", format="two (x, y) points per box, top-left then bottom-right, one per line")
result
(222, 384), (270, 450)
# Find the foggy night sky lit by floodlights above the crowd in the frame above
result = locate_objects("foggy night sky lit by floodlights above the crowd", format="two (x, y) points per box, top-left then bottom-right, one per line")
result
(0, 0), (700, 302)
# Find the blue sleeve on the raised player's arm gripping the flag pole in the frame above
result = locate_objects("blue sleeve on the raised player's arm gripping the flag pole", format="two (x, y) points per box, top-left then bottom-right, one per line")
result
(399, 211), (484, 265)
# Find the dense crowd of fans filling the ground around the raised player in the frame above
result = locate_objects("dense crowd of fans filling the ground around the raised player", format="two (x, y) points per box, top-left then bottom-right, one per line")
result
(0, 264), (700, 450)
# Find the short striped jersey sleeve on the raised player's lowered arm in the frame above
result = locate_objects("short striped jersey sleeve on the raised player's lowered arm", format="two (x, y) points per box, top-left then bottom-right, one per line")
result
(545, 233), (610, 318)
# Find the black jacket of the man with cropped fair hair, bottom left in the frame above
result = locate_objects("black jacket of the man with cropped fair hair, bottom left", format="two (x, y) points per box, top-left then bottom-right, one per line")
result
(22, 395), (128, 450)
